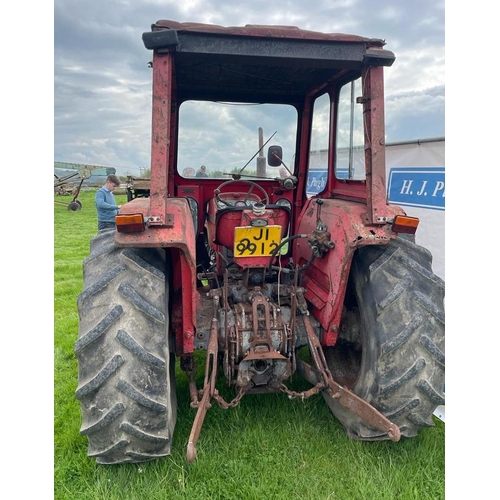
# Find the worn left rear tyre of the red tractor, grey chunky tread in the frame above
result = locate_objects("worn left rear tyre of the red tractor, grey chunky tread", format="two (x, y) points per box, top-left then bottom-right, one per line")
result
(75, 229), (177, 464)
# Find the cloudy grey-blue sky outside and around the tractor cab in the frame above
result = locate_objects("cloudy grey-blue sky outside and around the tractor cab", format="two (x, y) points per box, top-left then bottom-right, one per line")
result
(54, 0), (445, 175)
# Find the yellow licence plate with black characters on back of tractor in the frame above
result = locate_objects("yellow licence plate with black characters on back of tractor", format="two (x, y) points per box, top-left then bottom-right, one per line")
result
(234, 226), (281, 257)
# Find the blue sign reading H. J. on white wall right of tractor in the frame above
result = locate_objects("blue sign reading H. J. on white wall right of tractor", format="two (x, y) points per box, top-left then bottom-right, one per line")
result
(387, 166), (444, 210)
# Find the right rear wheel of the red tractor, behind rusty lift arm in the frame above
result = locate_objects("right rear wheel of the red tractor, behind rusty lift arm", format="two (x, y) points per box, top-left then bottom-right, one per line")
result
(323, 237), (445, 441)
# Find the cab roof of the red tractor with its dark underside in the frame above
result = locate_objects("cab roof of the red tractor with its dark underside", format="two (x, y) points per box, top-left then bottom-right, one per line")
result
(143, 20), (395, 103)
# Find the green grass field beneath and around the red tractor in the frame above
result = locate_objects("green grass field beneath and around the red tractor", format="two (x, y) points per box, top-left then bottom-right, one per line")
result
(54, 191), (445, 500)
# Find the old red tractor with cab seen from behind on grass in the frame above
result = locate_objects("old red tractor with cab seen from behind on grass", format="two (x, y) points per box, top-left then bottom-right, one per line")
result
(75, 21), (445, 464)
